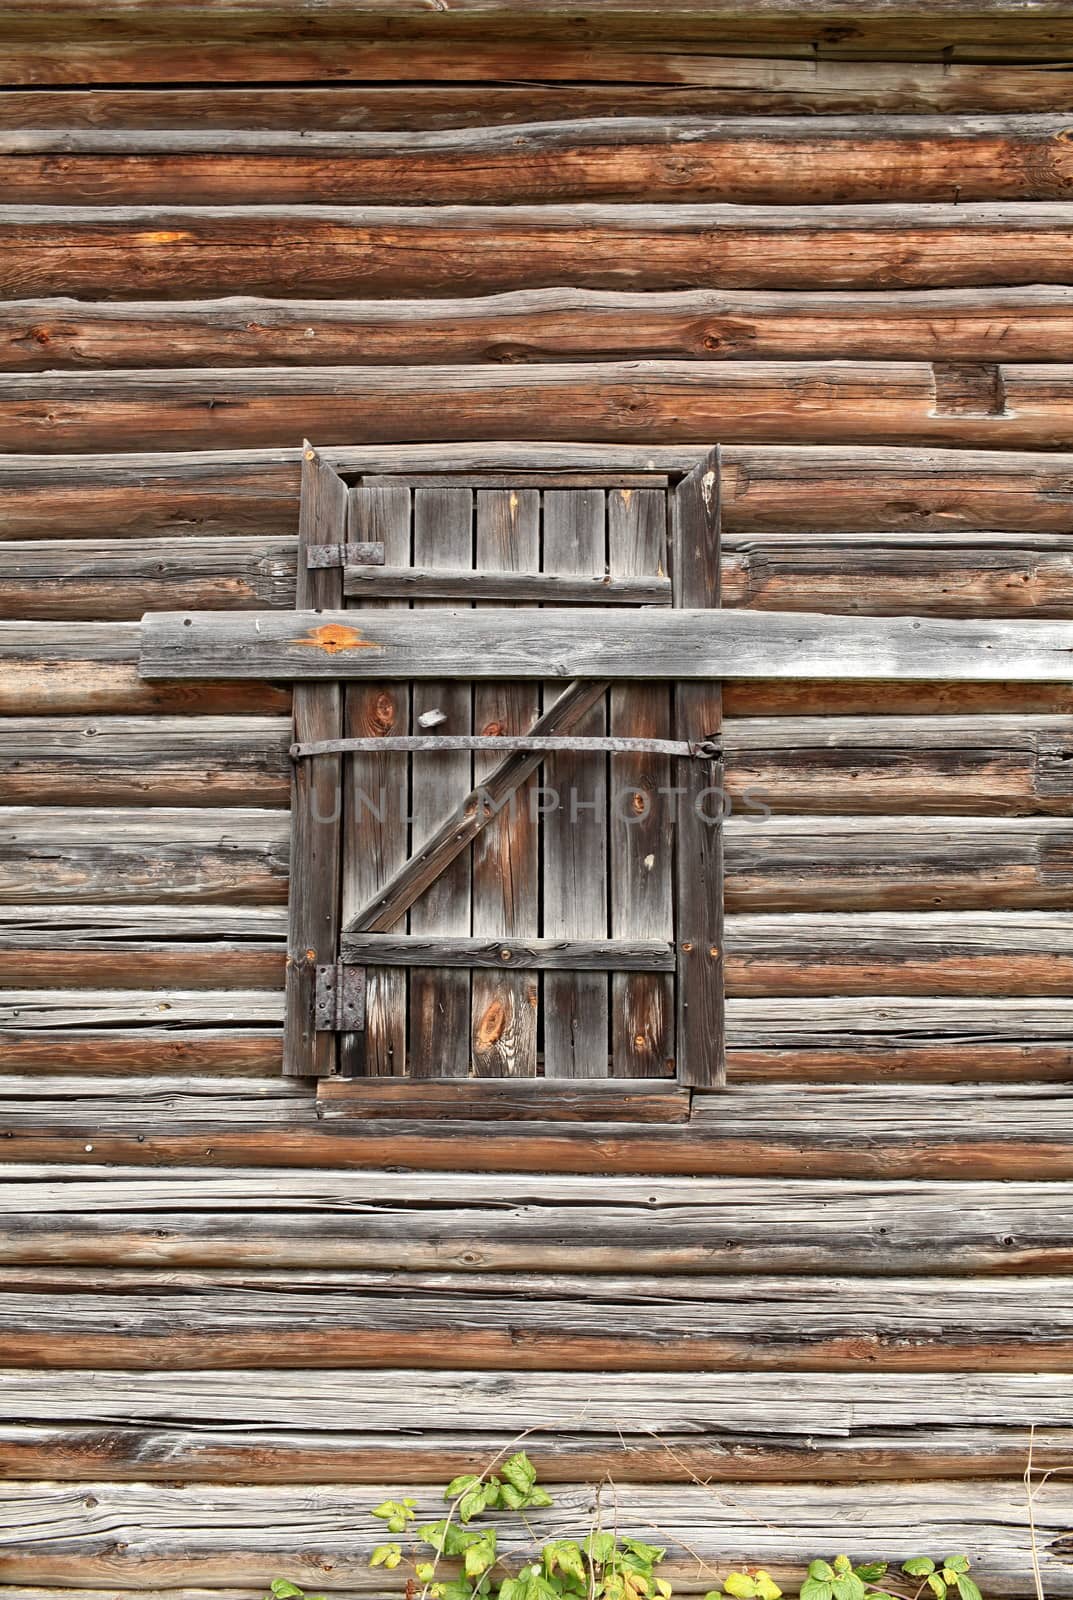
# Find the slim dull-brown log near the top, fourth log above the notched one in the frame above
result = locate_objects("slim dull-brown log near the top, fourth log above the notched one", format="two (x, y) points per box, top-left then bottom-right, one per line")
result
(0, 64), (1068, 122)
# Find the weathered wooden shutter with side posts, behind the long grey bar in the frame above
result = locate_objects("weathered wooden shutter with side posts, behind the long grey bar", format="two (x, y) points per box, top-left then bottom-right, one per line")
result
(286, 453), (723, 1085)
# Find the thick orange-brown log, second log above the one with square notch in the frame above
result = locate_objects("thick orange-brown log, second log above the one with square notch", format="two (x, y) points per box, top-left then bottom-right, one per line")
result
(8, 202), (1073, 299)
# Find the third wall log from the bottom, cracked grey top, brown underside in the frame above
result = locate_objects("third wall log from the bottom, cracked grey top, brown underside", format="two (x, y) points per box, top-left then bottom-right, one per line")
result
(0, 1260), (1073, 1376)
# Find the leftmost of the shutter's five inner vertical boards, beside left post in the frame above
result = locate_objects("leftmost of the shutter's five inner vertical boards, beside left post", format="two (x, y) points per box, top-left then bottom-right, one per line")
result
(339, 485), (409, 1077)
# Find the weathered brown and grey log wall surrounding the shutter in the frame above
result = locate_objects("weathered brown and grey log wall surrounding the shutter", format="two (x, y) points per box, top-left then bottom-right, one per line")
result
(0, 0), (1073, 1600)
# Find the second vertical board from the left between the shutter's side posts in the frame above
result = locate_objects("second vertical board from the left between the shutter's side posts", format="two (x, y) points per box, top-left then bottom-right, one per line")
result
(409, 488), (473, 1078)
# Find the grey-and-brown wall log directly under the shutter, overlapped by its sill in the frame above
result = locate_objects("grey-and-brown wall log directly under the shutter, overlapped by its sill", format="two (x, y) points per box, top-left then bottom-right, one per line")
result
(0, 1064), (1073, 1184)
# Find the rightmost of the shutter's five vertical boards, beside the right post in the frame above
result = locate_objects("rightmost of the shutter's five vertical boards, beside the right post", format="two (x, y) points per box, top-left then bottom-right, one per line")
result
(608, 490), (680, 1078)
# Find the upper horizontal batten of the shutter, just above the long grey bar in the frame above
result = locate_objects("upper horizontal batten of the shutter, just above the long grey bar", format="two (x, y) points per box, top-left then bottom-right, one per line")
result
(342, 569), (670, 605)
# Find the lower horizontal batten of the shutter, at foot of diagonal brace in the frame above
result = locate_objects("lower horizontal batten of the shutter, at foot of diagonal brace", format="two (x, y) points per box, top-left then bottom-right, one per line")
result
(342, 933), (675, 966)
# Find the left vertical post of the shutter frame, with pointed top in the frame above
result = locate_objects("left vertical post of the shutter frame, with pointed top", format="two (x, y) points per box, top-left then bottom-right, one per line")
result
(283, 445), (347, 1078)
